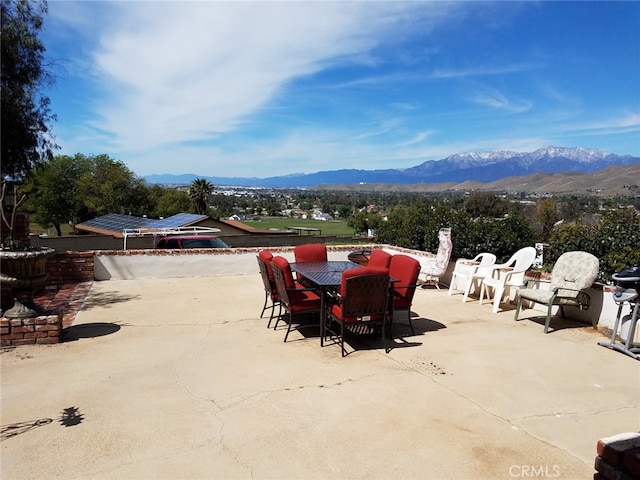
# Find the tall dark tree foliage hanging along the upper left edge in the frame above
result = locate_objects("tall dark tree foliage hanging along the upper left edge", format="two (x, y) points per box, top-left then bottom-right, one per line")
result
(0, 0), (57, 179)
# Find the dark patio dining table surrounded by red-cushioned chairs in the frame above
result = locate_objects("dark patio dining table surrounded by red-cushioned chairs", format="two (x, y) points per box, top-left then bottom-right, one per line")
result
(291, 261), (360, 346)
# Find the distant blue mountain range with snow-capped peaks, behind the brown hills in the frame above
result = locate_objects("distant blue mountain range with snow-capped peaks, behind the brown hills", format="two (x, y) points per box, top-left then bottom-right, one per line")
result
(144, 147), (640, 188)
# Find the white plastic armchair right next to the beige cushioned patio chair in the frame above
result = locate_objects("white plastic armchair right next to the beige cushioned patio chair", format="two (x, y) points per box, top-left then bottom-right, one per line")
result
(480, 247), (537, 313)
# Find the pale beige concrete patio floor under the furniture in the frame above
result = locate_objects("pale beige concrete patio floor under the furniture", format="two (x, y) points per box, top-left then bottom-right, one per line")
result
(0, 274), (640, 480)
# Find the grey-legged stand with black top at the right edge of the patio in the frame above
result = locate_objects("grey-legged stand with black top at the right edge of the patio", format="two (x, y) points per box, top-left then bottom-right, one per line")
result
(598, 267), (640, 360)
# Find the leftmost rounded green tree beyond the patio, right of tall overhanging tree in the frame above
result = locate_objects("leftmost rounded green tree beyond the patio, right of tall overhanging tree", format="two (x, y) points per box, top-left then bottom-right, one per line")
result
(26, 154), (91, 236)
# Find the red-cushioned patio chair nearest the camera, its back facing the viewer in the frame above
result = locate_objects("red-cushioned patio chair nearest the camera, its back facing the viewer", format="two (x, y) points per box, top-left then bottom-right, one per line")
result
(328, 266), (390, 357)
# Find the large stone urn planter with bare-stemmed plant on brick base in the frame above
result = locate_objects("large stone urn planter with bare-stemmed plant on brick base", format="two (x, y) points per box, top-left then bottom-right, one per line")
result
(0, 182), (55, 318)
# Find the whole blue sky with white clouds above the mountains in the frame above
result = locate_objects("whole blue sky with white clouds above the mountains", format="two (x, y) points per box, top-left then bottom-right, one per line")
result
(41, 0), (640, 177)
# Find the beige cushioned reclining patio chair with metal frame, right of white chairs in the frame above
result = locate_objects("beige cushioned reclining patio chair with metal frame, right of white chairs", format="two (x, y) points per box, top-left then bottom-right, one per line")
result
(515, 251), (600, 333)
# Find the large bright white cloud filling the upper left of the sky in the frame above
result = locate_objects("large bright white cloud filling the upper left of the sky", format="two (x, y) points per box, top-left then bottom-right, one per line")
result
(63, 2), (450, 150)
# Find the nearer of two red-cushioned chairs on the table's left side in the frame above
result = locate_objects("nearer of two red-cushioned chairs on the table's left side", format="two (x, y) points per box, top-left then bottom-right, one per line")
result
(271, 256), (320, 342)
